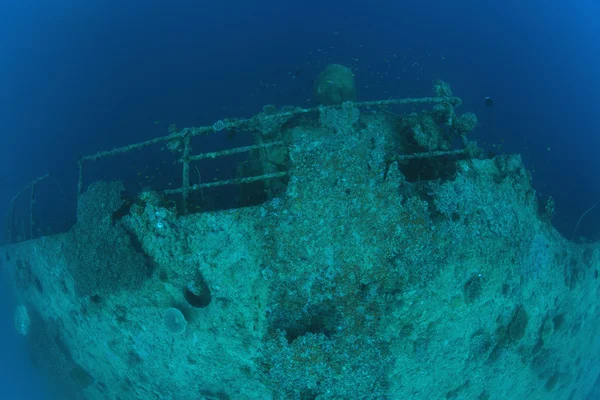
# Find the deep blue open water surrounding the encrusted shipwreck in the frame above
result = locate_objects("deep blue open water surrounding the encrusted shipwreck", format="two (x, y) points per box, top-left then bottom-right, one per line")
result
(0, 0), (600, 399)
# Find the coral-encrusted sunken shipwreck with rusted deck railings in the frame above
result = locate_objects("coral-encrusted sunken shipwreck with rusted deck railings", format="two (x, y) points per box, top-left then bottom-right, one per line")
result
(0, 82), (600, 400)
